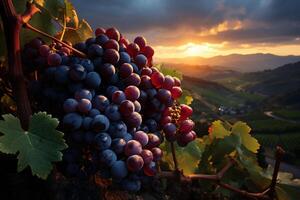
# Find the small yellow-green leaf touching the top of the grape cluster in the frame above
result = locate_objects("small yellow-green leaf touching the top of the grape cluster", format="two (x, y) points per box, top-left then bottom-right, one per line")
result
(57, 19), (93, 44)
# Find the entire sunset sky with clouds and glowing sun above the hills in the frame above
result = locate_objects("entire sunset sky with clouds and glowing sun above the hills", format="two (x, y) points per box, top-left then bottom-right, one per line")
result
(72, 0), (300, 59)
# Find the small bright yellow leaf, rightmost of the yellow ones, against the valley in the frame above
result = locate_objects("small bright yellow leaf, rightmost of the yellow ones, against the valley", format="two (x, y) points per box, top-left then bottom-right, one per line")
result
(232, 122), (260, 153)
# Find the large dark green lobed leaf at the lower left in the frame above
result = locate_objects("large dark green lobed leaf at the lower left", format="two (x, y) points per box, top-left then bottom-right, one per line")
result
(0, 112), (67, 179)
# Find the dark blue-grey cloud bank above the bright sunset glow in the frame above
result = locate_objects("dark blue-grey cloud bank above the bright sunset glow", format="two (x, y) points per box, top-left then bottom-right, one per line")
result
(72, 0), (300, 43)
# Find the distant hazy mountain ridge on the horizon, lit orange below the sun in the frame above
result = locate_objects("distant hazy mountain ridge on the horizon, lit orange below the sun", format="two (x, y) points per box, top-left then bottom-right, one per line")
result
(157, 53), (300, 74)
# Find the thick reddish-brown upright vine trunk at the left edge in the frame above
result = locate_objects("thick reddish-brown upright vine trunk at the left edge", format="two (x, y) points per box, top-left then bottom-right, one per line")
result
(0, 0), (40, 130)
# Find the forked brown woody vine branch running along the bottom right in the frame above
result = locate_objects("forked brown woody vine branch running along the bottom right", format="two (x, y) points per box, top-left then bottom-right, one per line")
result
(157, 147), (284, 200)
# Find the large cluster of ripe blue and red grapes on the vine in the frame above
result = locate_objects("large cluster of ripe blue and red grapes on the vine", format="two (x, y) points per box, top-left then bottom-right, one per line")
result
(23, 28), (195, 191)
